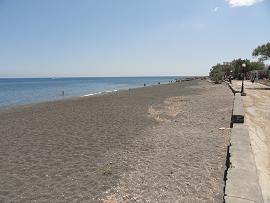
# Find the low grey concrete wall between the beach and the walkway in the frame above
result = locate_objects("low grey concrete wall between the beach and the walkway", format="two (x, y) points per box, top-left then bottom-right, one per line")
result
(224, 85), (263, 203)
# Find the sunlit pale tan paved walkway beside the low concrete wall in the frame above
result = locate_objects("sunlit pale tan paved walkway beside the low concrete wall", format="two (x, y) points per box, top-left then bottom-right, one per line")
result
(233, 81), (270, 203)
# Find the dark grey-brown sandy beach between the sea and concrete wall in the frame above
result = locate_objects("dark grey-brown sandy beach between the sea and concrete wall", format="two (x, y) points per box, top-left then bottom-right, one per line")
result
(0, 80), (233, 203)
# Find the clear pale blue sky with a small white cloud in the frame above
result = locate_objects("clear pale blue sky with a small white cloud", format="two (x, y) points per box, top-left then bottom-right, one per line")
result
(0, 0), (270, 77)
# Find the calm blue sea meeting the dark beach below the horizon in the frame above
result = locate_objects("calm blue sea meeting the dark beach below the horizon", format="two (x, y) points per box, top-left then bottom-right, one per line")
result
(0, 76), (179, 107)
